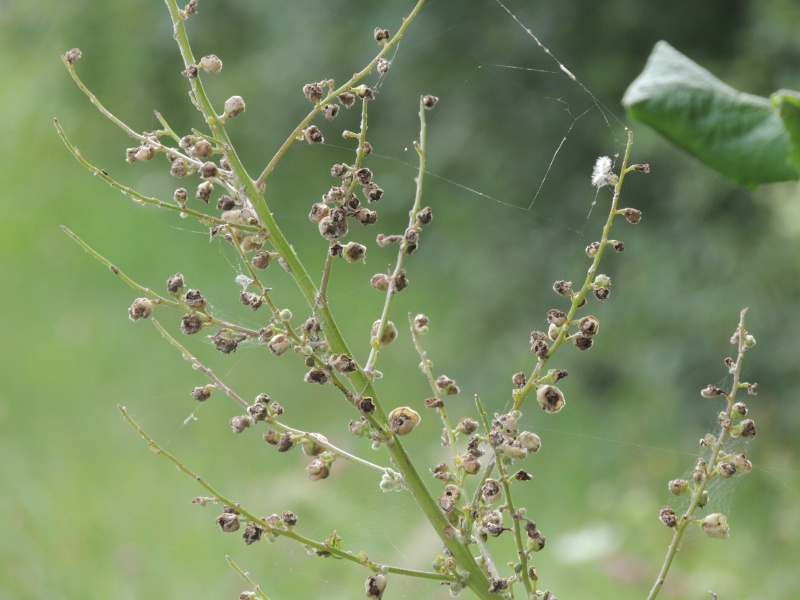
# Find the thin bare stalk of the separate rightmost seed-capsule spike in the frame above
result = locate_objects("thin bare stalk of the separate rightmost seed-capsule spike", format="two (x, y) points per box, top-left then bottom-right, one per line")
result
(647, 308), (748, 600)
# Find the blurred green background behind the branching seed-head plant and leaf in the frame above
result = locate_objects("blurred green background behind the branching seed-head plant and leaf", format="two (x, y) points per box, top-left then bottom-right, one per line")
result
(0, 0), (800, 600)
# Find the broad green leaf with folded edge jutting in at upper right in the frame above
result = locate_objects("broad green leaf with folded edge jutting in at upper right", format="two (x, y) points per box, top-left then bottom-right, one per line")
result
(622, 41), (800, 188)
